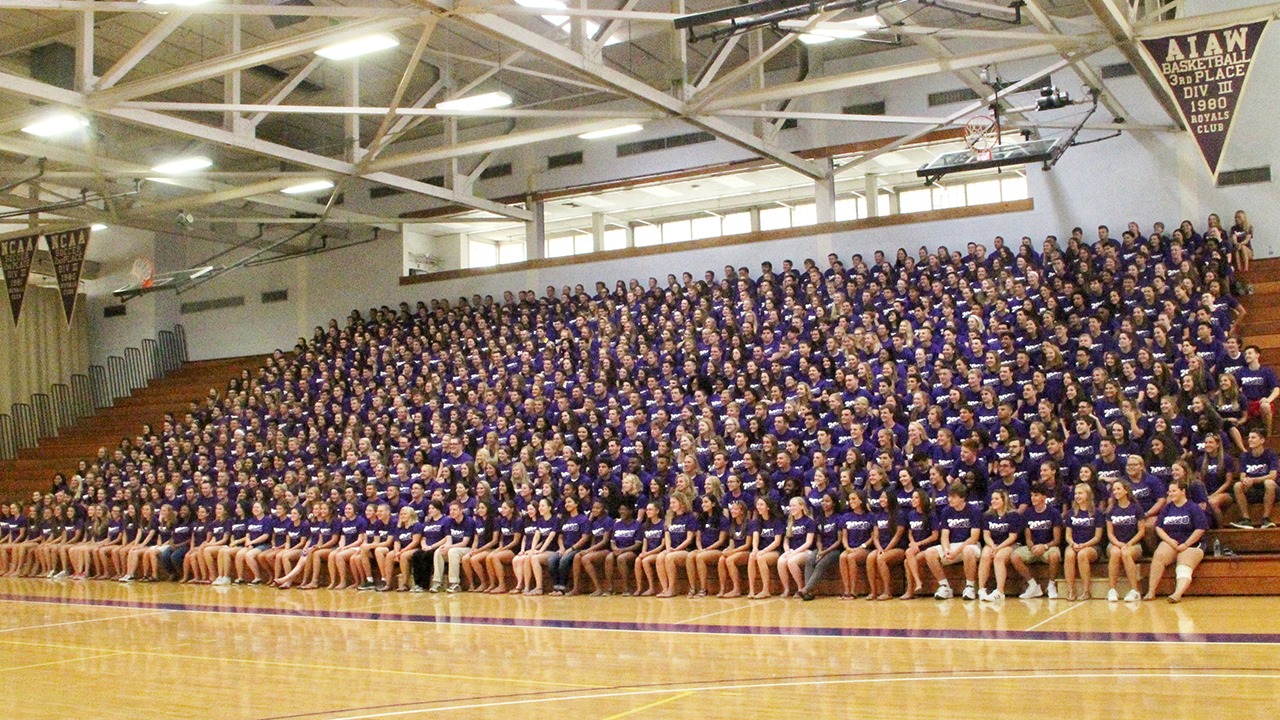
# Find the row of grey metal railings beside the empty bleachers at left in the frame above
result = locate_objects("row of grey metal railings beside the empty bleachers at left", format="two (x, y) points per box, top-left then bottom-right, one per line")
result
(0, 325), (187, 460)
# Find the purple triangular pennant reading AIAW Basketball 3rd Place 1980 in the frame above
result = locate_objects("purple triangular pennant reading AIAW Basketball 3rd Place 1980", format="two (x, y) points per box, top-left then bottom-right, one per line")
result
(1142, 20), (1270, 178)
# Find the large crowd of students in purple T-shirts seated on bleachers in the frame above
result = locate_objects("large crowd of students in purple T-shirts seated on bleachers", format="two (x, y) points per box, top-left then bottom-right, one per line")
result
(0, 211), (1264, 601)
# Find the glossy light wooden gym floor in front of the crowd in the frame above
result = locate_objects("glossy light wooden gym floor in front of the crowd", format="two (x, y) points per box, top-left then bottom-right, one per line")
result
(0, 579), (1280, 720)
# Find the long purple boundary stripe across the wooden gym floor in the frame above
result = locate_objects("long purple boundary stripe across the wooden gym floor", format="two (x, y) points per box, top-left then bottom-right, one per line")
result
(0, 593), (1280, 644)
